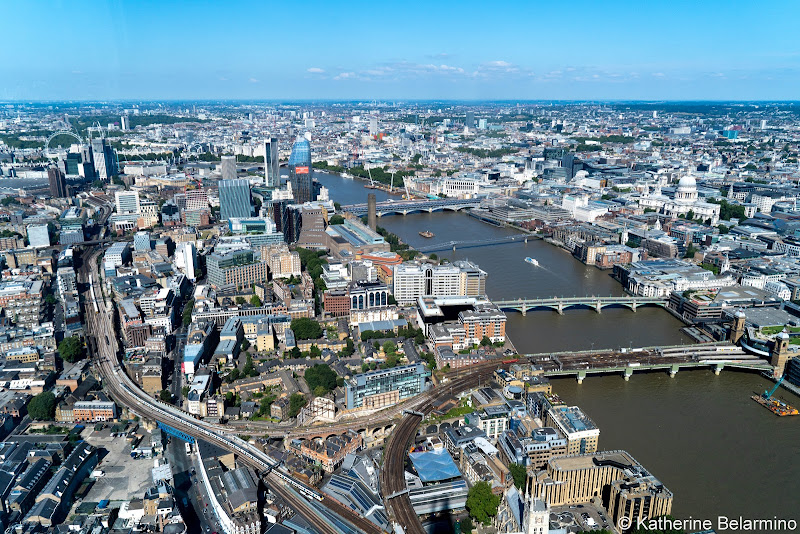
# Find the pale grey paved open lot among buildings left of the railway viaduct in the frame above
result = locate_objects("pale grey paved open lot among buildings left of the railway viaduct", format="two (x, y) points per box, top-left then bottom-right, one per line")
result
(81, 427), (153, 502)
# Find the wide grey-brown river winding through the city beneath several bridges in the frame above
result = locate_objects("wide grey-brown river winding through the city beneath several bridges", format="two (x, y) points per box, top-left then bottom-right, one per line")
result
(316, 173), (800, 532)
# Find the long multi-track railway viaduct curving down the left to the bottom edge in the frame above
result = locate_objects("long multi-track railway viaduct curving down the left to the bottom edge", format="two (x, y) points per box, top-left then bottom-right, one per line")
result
(79, 247), (372, 534)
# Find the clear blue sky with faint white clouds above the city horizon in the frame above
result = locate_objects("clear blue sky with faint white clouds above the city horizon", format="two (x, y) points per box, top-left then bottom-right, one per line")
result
(0, 0), (800, 100)
